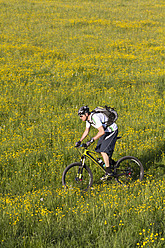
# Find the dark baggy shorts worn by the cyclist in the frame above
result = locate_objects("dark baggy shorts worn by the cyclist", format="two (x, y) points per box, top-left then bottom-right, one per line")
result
(95, 130), (118, 157)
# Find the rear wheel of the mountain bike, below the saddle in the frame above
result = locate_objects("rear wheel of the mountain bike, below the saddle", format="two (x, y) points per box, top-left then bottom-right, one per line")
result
(114, 156), (144, 185)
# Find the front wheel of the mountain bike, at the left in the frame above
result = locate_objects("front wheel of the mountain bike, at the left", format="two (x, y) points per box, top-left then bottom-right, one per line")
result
(62, 163), (93, 191)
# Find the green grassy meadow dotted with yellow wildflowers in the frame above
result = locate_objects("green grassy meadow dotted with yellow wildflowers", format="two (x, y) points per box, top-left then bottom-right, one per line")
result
(0, 0), (165, 248)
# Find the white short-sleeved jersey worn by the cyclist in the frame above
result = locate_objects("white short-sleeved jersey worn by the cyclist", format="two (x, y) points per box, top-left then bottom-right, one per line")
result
(86, 113), (118, 132)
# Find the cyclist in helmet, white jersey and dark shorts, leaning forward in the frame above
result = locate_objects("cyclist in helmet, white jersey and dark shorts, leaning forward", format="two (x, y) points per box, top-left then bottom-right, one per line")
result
(75, 106), (118, 180)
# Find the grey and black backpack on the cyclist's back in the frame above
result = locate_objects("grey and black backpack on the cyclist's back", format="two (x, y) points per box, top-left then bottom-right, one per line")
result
(91, 105), (118, 126)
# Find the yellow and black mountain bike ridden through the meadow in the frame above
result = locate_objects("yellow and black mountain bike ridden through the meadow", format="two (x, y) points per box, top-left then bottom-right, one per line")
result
(62, 137), (144, 191)
